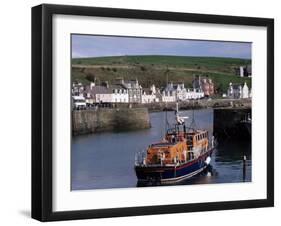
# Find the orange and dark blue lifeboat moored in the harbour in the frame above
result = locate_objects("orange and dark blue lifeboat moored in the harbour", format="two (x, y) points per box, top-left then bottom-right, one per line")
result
(135, 105), (215, 184)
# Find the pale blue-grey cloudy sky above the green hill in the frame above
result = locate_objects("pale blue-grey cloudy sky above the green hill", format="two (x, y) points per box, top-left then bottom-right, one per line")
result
(72, 35), (251, 59)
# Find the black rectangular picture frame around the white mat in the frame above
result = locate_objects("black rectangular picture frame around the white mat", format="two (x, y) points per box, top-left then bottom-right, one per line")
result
(32, 4), (274, 221)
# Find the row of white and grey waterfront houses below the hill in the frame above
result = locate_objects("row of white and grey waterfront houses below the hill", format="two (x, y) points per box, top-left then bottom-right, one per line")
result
(72, 76), (249, 104)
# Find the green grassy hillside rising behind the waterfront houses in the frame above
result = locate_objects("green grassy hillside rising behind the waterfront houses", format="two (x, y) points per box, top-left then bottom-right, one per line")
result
(72, 56), (251, 93)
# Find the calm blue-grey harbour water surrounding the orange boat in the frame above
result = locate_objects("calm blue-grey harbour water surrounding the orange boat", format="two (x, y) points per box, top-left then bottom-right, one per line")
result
(71, 109), (251, 190)
